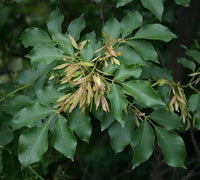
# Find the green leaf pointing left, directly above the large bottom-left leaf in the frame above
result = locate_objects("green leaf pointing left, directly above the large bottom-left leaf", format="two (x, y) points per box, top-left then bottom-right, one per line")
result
(12, 102), (54, 129)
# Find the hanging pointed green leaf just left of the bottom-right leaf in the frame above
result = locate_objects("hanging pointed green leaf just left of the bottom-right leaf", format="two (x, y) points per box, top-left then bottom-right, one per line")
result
(131, 120), (155, 169)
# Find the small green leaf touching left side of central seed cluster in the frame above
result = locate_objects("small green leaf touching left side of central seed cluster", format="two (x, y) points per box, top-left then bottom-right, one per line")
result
(36, 85), (64, 105)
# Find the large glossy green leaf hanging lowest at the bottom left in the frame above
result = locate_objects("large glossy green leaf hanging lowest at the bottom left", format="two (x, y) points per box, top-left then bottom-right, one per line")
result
(18, 123), (48, 167)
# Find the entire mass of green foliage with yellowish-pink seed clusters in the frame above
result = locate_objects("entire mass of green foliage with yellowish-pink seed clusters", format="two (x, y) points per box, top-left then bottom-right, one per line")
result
(0, 0), (200, 179)
